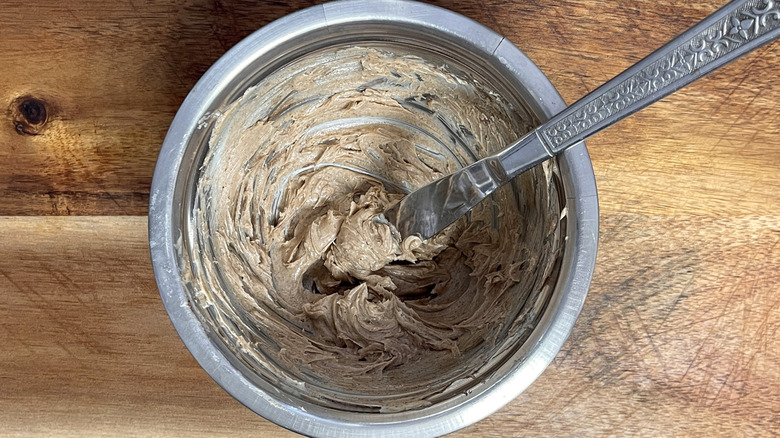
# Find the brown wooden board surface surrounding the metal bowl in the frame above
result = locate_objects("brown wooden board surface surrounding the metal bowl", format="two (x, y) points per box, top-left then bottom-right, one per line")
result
(0, 0), (780, 437)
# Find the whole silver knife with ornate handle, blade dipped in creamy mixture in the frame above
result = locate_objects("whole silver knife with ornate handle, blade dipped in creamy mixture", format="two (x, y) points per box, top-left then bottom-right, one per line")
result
(385, 0), (780, 239)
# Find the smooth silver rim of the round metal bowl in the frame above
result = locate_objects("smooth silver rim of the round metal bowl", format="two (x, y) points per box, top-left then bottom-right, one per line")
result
(148, 0), (598, 437)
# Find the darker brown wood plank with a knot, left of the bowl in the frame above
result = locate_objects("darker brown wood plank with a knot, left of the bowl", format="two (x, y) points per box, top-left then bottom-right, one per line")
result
(0, 0), (316, 215)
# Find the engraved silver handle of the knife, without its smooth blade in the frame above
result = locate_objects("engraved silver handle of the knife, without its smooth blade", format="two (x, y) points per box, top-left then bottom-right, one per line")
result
(537, 0), (780, 155)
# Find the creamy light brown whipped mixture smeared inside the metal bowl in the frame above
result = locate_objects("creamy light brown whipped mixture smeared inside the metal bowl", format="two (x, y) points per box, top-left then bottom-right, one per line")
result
(183, 48), (560, 412)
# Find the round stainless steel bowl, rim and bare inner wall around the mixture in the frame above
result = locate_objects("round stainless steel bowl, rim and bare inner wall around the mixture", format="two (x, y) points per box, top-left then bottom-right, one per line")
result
(149, 0), (598, 437)
